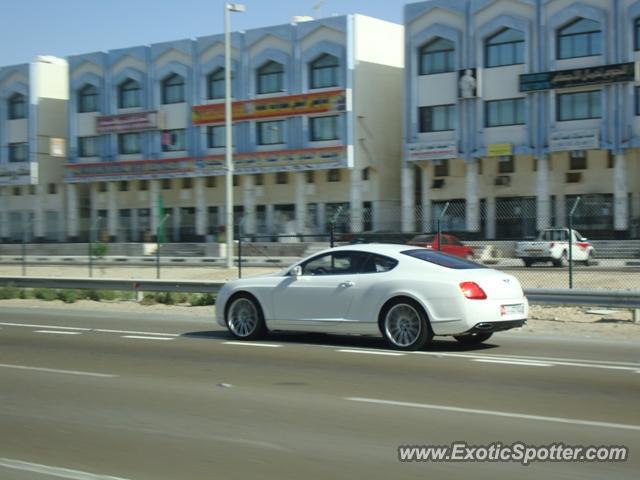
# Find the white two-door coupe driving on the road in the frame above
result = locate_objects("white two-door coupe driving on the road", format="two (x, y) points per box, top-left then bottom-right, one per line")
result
(216, 244), (529, 350)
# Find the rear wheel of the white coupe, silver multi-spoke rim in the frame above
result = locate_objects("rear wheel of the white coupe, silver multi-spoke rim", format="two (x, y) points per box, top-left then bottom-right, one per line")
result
(380, 298), (433, 350)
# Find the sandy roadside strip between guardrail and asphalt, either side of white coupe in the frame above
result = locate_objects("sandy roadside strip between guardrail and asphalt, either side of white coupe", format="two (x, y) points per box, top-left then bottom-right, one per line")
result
(0, 300), (640, 341)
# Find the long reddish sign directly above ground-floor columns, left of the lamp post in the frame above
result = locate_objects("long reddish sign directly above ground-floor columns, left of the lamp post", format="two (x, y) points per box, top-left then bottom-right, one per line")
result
(65, 158), (195, 183)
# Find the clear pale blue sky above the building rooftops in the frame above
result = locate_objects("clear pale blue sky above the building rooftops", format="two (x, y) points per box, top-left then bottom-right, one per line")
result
(0, 0), (408, 66)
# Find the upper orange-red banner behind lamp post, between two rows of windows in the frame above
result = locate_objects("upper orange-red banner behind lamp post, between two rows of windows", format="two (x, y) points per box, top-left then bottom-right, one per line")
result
(191, 90), (346, 125)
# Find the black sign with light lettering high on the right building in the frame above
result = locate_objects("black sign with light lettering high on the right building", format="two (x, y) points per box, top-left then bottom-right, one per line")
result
(520, 63), (635, 92)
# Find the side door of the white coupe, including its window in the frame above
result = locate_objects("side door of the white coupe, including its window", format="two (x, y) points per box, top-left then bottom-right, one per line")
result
(273, 250), (368, 330)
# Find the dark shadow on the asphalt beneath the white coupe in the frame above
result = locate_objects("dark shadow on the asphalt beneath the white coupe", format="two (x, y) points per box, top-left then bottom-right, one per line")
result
(181, 330), (499, 352)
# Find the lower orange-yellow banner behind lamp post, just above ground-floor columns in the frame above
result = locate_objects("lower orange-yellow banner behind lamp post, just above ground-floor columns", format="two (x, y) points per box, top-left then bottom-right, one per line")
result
(198, 147), (348, 175)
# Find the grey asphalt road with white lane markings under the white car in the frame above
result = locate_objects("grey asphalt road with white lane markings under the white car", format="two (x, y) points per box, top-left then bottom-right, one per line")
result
(0, 308), (640, 480)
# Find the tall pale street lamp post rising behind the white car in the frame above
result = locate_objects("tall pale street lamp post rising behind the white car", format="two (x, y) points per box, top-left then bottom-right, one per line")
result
(224, 2), (245, 268)
